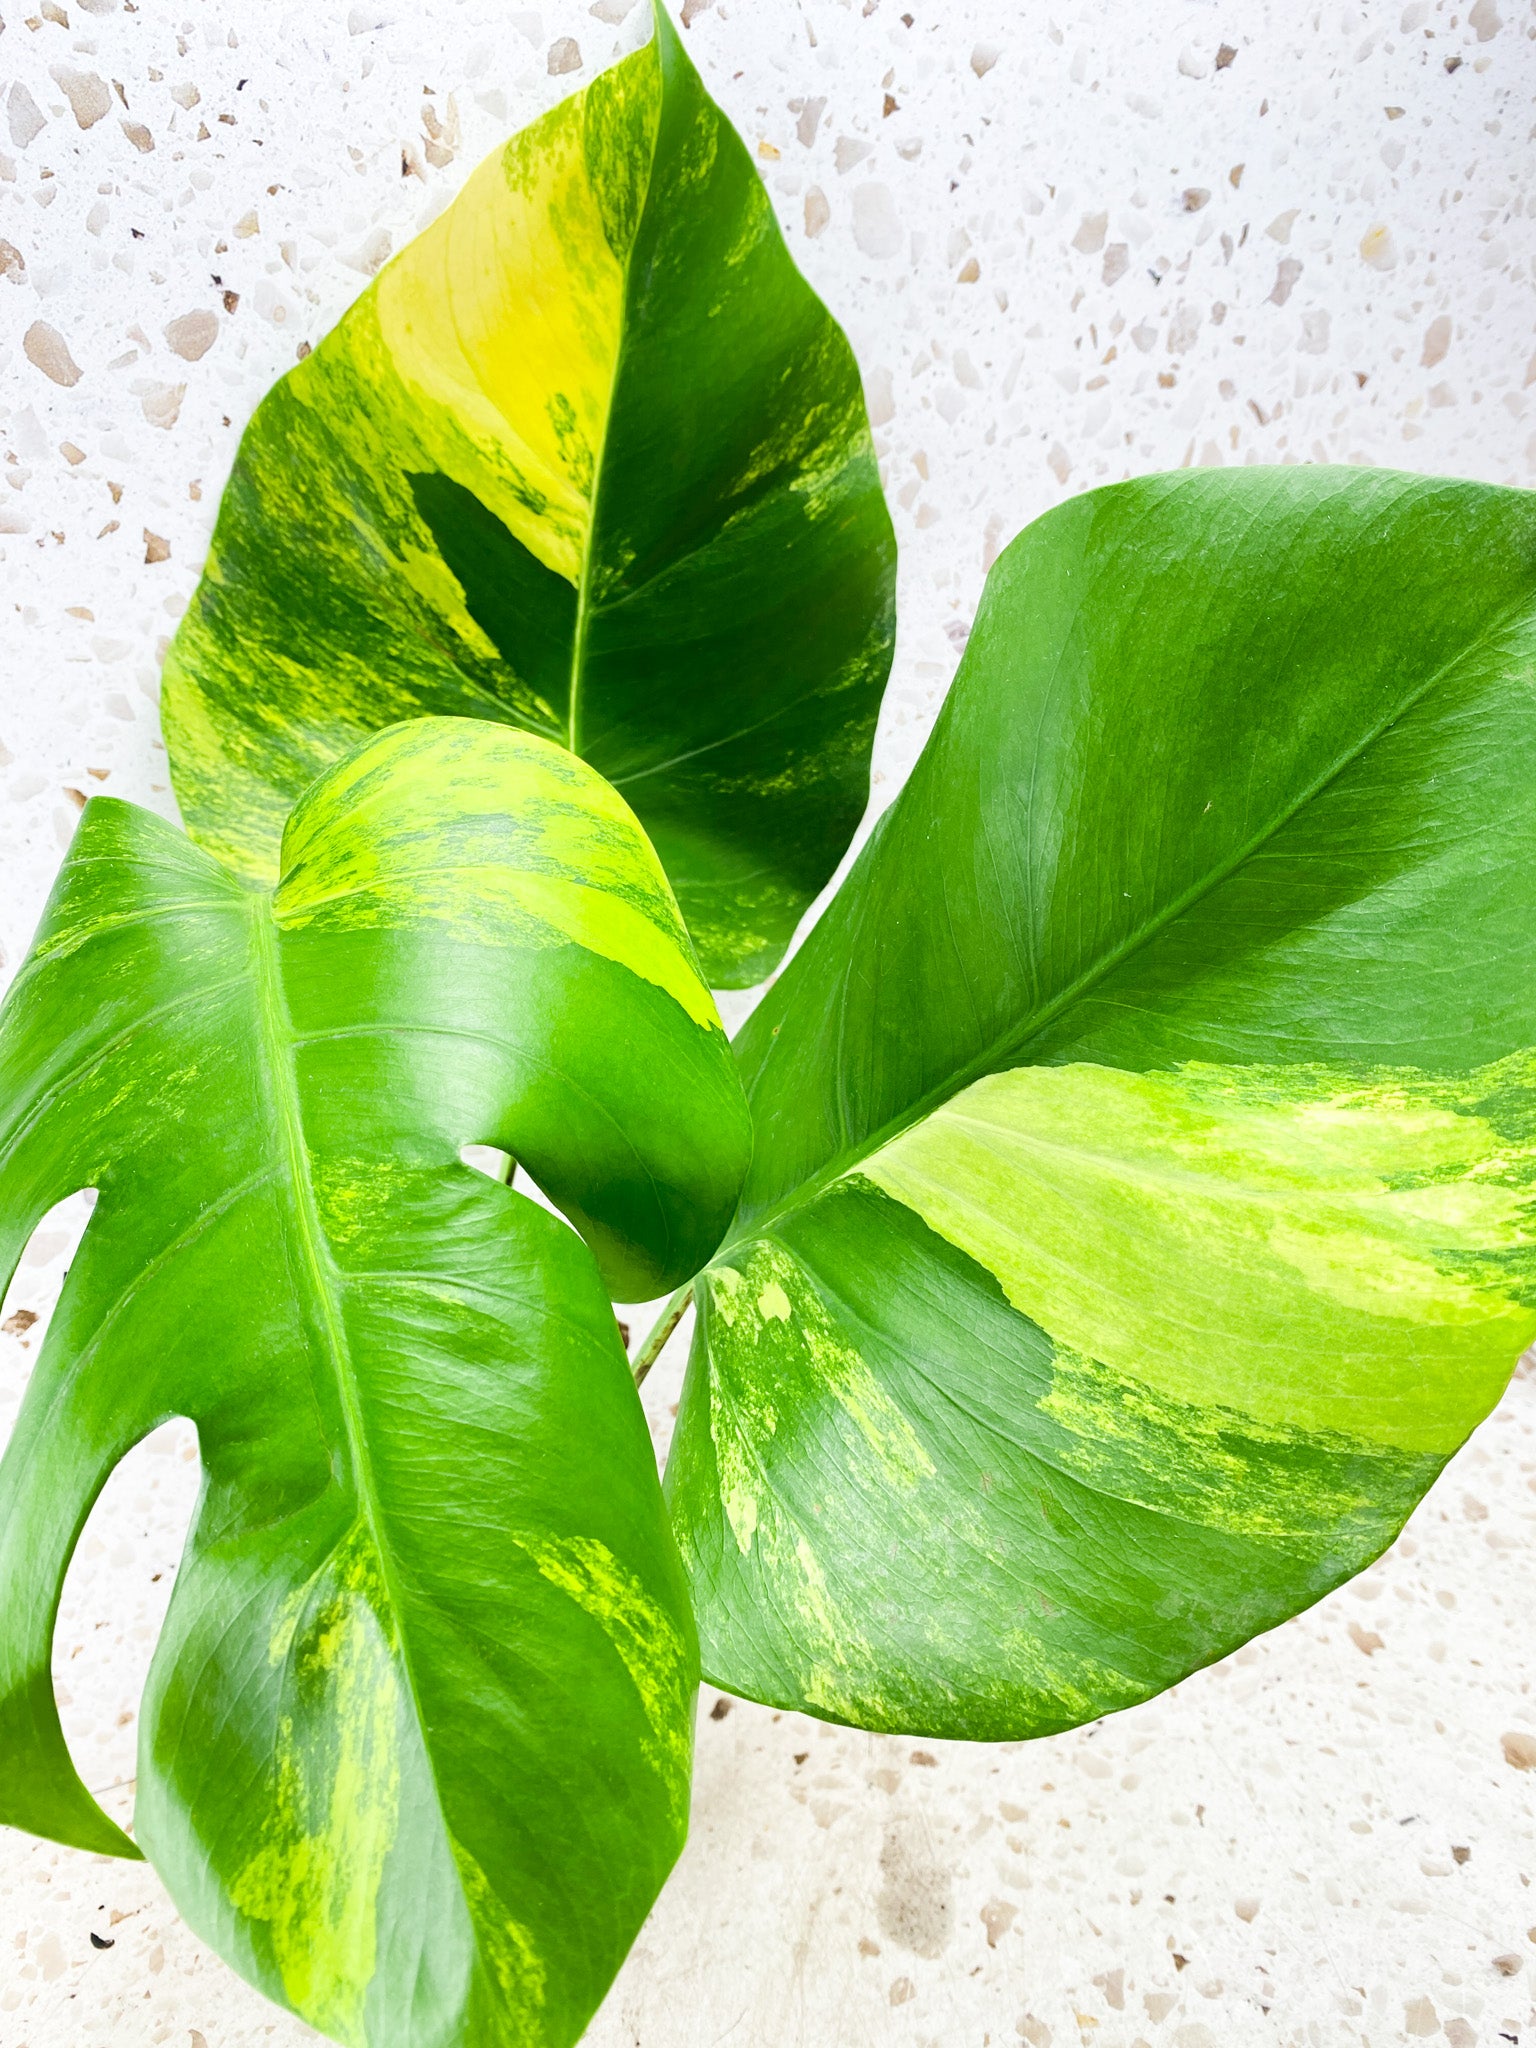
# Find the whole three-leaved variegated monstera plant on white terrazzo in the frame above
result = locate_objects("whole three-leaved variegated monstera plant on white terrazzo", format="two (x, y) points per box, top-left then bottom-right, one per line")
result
(0, 6), (1536, 2048)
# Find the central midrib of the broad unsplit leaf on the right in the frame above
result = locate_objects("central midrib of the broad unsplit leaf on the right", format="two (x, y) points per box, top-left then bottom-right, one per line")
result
(729, 600), (1530, 1264)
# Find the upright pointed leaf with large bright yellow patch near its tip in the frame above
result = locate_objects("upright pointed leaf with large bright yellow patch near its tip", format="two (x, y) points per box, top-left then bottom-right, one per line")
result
(164, 0), (895, 987)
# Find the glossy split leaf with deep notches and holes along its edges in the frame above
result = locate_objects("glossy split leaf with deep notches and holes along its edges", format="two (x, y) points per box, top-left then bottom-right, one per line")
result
(0, 719), (750, 2048)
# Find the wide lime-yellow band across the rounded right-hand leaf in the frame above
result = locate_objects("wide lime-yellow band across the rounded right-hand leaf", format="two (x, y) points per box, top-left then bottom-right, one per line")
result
(858, 1053), (1536, 1452)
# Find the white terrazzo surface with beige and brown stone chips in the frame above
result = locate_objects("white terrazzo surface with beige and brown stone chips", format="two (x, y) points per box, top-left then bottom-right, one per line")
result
(0, 0), (1536, 2048)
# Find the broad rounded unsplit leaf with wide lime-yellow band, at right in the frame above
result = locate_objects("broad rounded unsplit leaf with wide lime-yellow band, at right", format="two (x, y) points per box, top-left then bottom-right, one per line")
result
(668, 469), (1536, 1737)
